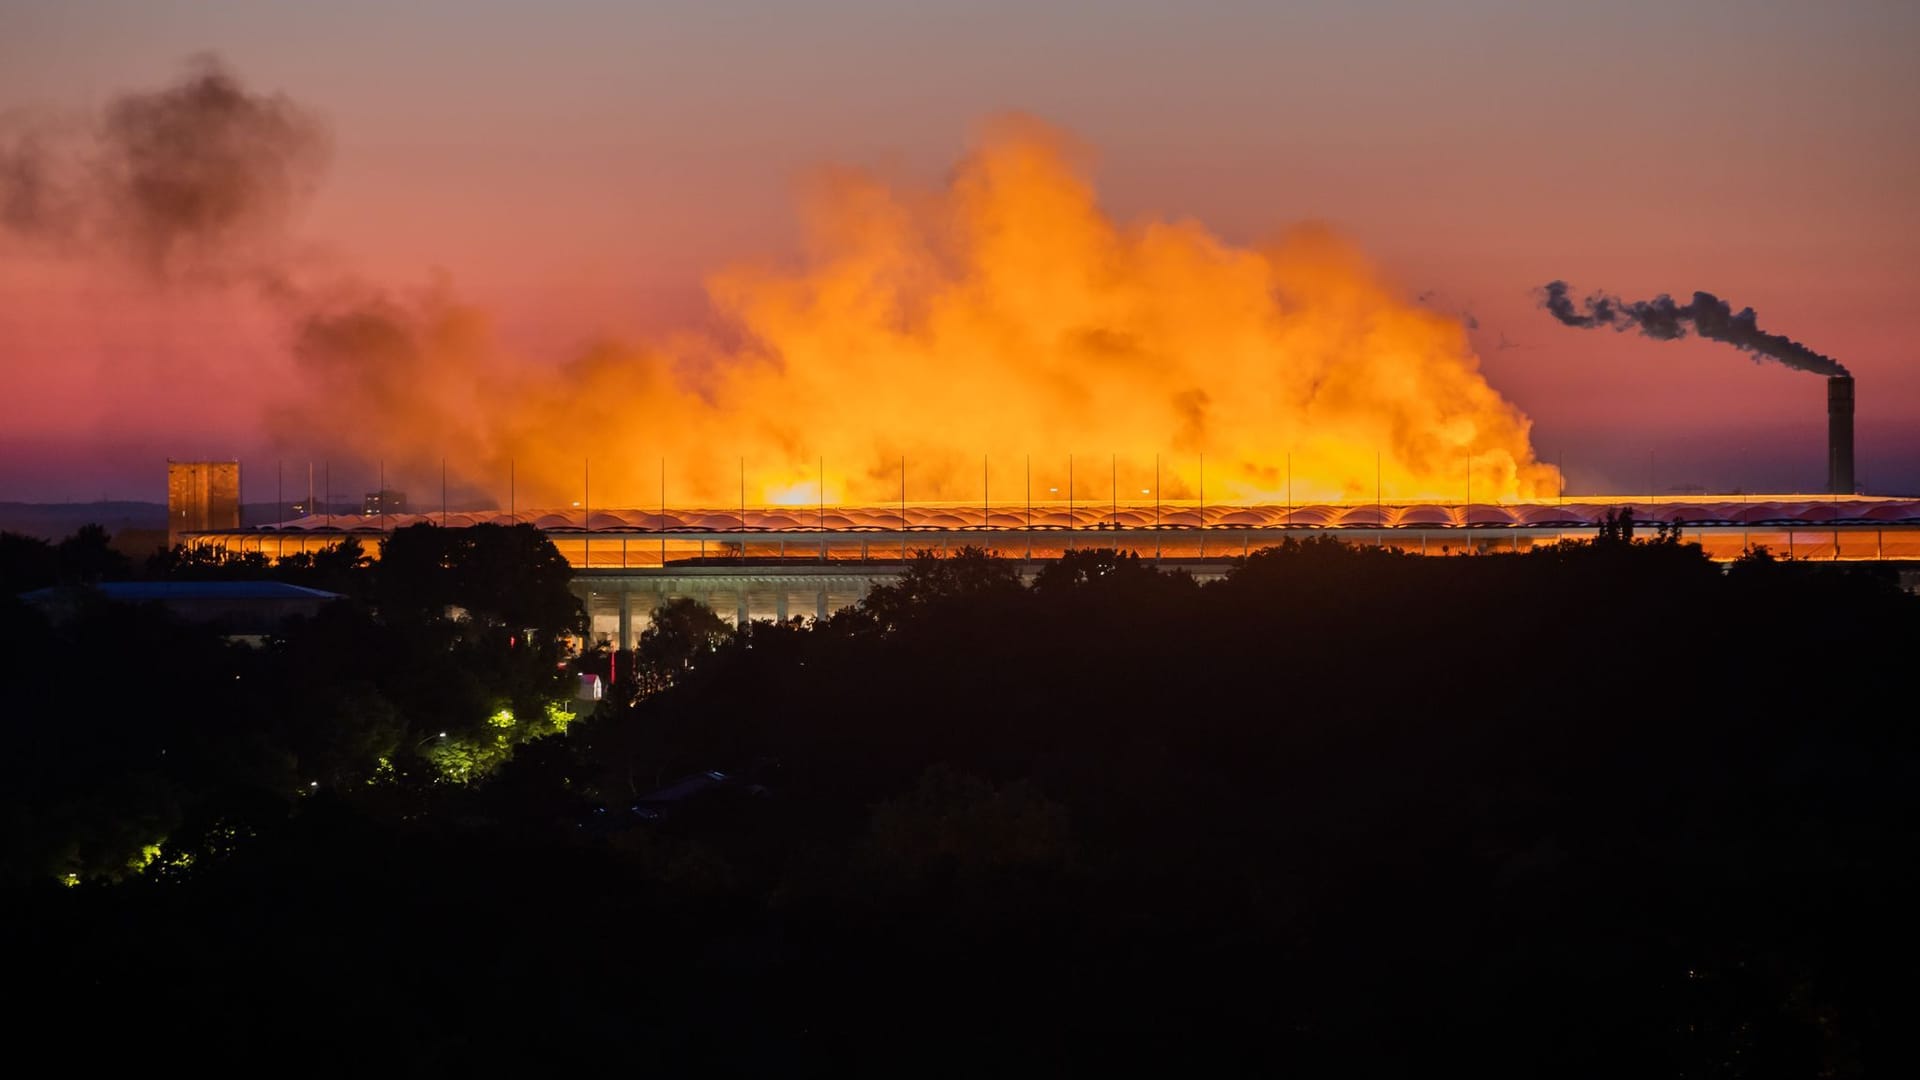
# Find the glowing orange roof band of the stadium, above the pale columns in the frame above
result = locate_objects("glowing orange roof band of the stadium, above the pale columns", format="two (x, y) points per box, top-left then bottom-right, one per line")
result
(188, 494), (1920, 569)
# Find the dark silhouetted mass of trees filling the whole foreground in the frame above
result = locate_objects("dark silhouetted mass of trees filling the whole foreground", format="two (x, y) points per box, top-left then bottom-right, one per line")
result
(6, 528), (1920, 1076)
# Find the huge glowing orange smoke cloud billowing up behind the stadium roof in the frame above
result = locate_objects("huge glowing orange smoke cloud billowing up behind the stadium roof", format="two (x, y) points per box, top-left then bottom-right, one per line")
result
(284, 119), (1559, 507)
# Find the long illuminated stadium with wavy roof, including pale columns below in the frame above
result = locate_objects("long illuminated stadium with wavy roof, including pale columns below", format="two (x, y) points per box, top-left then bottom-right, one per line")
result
(188, 496), (1920, 646)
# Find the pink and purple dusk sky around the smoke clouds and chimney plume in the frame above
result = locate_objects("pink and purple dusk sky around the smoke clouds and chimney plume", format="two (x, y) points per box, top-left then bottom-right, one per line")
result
(0, 0), (1920, 502)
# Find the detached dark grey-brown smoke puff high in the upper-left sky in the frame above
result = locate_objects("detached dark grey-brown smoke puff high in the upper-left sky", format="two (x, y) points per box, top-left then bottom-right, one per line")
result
(0, 58), (328, 281)
